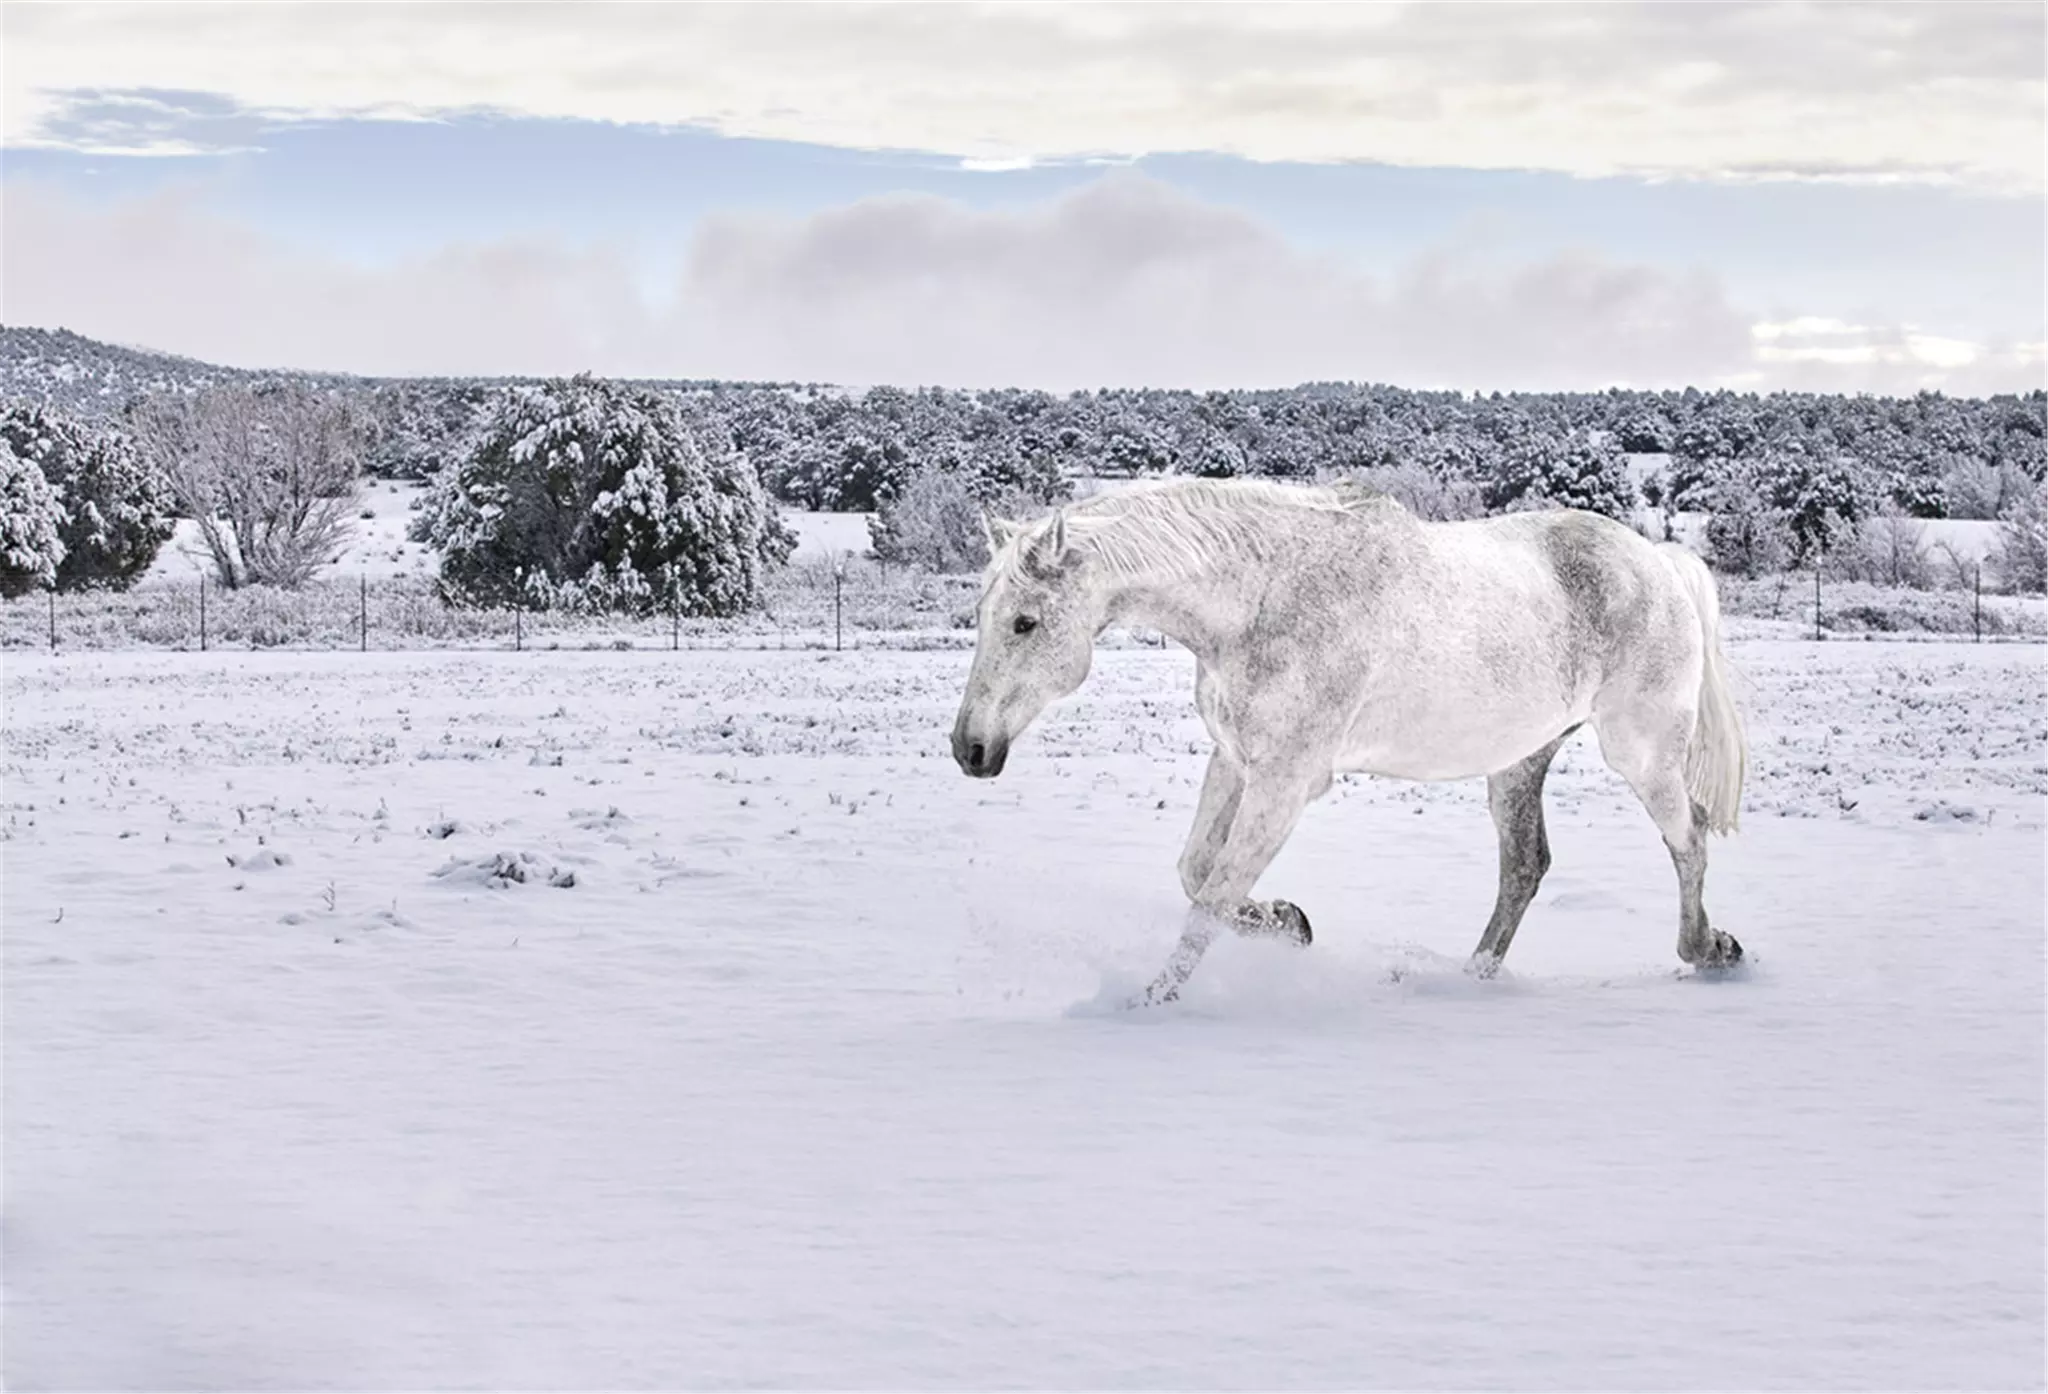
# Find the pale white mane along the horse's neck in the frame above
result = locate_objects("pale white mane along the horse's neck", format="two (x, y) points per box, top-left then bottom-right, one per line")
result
(987, 479), (1405, 581)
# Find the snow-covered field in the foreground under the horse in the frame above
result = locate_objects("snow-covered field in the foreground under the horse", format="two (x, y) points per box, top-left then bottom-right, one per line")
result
(0, 643), (2048, 1390)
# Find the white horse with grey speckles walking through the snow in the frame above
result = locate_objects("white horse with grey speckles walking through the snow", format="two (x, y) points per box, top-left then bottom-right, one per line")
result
(952, 481), (1747, 1003)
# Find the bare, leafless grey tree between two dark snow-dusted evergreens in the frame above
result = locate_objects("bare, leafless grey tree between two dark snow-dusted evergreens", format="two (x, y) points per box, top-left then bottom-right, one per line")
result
(135, 383), (367, 587)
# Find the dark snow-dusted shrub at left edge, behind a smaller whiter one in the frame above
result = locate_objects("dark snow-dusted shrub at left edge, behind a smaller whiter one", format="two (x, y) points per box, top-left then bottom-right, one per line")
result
(0, 403), (176, 590)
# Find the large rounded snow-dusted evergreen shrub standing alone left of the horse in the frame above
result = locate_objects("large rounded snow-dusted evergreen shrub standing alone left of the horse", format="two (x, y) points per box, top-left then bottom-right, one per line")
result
(414, 377), (788, 616)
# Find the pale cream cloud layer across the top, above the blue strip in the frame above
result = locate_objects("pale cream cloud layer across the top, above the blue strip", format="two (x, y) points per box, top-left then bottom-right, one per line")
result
(0, 2), (2048, 194)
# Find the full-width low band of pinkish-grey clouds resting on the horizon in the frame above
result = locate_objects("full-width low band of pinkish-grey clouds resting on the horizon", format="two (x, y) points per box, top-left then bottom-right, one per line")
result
(0, 172), (2040, 391)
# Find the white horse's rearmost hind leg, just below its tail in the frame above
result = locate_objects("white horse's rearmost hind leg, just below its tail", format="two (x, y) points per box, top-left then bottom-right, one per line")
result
(1593, 704), (1743, 968)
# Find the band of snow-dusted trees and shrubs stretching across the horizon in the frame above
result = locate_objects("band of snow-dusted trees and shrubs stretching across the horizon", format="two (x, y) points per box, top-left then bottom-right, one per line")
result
(0, 377), (2048, 614)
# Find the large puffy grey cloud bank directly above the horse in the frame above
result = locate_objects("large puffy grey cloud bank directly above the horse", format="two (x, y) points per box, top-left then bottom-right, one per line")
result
(686, 174), (1749, 387)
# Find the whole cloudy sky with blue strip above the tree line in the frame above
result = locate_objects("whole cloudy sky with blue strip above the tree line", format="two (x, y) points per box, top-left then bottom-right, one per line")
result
(0, 0), (2048, 395)
